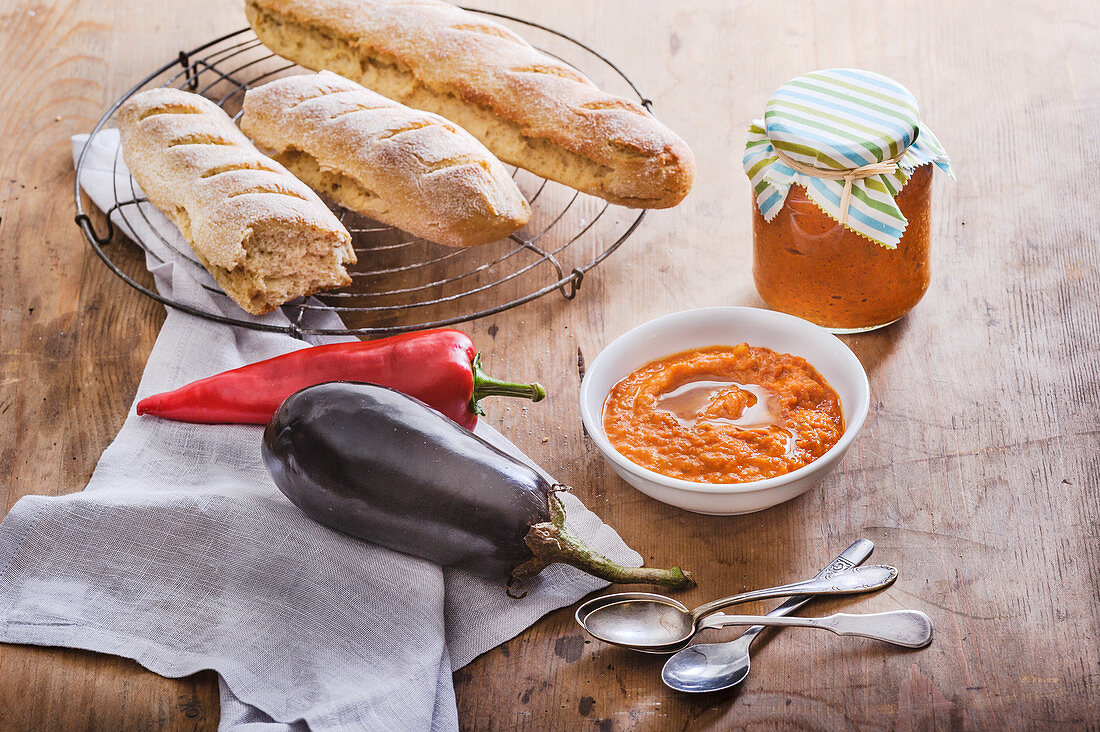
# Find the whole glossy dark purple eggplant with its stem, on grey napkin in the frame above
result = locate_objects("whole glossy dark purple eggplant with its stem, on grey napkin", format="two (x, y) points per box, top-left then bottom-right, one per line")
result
(263, 382), (694, 588)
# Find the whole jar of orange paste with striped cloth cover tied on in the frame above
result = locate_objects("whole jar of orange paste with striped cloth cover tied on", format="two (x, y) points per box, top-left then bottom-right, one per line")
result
(743, 68), (954, 332)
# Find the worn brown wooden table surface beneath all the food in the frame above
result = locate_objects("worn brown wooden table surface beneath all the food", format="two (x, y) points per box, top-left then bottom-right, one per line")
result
(0, 0), (1100, 730)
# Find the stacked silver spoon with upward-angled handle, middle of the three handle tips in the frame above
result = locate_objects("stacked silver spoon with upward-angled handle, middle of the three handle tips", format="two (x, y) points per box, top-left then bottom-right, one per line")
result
(576, 565), (898, 653)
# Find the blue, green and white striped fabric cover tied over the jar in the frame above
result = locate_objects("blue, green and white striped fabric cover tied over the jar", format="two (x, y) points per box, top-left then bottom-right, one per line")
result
(743, 68), (955, 249)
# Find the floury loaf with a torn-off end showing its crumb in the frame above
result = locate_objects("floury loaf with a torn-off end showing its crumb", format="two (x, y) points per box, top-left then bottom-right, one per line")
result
(119, 88), (355, 315)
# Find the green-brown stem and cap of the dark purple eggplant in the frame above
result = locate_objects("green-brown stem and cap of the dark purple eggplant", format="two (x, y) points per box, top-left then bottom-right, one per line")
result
(512, 491), (695, 590)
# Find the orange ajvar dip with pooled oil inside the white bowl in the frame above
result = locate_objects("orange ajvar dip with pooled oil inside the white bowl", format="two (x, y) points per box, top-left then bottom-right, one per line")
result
(603, 343), (844, 483)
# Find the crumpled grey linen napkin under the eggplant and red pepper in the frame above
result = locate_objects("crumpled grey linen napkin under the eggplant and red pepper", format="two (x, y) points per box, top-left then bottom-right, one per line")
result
(0, 131), (641, 730)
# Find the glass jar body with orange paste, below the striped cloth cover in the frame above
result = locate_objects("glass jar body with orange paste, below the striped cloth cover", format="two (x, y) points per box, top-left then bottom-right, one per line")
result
(752, 163), (933, 332)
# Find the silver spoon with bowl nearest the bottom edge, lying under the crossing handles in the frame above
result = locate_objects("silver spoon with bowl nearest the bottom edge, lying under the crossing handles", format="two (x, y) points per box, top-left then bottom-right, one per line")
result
(661, 539), (875, 693)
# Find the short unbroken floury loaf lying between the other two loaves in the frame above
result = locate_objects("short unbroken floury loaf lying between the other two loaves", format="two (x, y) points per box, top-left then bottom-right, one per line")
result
(241, 72), (531, 247)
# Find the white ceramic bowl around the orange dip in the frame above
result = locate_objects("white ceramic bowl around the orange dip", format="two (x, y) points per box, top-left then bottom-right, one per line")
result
(581, 307), (870, 515)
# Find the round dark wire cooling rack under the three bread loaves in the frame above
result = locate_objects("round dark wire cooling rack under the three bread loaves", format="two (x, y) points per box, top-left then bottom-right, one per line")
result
(75, 9), (650, 337)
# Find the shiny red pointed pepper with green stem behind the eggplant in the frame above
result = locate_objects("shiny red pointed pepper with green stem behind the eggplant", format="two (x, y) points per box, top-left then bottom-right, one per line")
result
(138, 329), (546, 429)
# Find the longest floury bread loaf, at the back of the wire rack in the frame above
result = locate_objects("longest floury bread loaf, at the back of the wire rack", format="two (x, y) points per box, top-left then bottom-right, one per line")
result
(245, 0), (695, 208)
